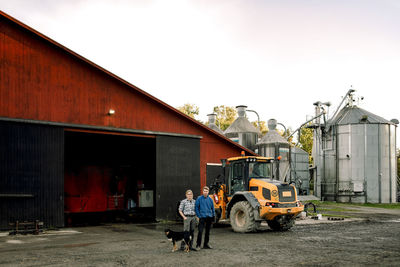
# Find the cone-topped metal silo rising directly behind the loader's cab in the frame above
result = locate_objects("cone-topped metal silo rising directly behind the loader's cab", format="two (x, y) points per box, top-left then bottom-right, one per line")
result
(256, 119), (290, 181)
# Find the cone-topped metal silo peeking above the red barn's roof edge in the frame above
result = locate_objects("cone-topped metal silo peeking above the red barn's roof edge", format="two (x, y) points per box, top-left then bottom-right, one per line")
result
(224, 106), (260, 150)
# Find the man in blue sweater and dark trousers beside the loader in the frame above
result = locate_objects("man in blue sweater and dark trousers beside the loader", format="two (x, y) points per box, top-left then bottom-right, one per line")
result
(196, 186), (215, 249)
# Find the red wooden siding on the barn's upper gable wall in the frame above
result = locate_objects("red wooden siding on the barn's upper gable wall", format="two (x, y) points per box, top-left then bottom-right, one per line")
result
(0, 12), (252, 185)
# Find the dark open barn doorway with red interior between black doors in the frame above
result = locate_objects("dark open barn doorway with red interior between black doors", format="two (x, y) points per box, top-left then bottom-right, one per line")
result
(64, 129), (156, 225)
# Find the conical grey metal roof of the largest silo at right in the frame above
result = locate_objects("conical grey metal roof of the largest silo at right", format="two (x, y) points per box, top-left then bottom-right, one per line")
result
(328, 106), (393, 125)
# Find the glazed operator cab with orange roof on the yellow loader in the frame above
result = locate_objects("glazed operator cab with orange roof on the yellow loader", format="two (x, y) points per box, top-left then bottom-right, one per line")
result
(223, 156), (273, 195)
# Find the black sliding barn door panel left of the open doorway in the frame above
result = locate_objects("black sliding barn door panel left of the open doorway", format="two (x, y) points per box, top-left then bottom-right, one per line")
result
(0, 121), (64, 229)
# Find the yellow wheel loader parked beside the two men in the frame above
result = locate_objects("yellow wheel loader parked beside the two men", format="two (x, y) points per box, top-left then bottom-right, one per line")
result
(210, 155), (304, 233)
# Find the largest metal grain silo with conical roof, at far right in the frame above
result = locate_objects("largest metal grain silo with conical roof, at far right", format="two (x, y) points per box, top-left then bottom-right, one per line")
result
(313, 91), (397, 203)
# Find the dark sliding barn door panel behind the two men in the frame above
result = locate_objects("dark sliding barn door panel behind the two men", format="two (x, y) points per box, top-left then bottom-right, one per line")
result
(156, 136), (200, 220)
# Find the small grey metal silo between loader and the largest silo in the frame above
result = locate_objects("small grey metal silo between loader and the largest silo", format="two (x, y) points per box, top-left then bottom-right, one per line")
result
(290, 147), (310, 195)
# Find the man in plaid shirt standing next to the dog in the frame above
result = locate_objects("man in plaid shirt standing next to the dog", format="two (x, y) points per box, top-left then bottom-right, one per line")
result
(179, 190), (196, 251)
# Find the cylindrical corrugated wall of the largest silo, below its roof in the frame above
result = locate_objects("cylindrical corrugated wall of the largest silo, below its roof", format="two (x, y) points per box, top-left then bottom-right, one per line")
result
(338, 124), (396, 203)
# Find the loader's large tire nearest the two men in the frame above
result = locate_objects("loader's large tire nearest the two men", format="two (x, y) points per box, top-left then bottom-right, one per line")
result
(230, 201), (260, 233)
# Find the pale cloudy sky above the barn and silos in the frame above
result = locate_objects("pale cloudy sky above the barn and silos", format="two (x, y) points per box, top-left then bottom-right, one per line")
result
(0, 0), (400, 147)
